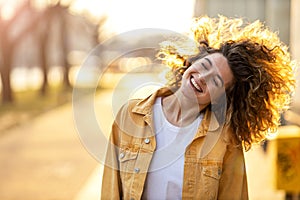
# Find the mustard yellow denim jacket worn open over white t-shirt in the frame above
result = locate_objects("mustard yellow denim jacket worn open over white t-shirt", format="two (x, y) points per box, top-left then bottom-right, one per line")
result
(101, 88), (248, 200)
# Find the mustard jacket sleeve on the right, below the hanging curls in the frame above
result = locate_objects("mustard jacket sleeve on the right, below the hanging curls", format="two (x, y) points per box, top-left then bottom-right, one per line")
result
(218, 146), (248, 200)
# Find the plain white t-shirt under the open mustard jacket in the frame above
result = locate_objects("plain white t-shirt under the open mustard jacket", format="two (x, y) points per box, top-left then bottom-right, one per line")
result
(142, 98), (203, 200)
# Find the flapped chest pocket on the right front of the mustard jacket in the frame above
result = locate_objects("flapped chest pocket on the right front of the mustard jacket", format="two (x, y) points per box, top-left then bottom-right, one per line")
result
(200, 164), (222, 200)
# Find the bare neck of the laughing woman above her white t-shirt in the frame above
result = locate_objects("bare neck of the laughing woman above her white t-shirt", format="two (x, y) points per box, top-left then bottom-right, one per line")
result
(162, 92), (205, 126)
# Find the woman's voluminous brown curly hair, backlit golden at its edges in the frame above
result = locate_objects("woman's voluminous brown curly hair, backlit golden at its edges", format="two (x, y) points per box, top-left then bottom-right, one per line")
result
(158, 16), (296, 150)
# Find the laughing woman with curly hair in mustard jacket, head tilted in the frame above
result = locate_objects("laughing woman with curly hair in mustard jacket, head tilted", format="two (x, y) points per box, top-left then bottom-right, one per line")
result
(101, 16), (295, 200)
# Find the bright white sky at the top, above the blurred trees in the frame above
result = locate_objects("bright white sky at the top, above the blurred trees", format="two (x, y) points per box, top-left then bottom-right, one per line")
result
(0, 0), (194, 33)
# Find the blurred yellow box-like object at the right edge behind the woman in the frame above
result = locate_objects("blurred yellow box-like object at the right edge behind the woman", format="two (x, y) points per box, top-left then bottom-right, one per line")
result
(270, 125), (300, 193)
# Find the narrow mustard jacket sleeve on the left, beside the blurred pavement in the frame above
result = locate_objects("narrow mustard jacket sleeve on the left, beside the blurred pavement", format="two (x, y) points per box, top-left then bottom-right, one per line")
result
(101, 123), (122, 200)
